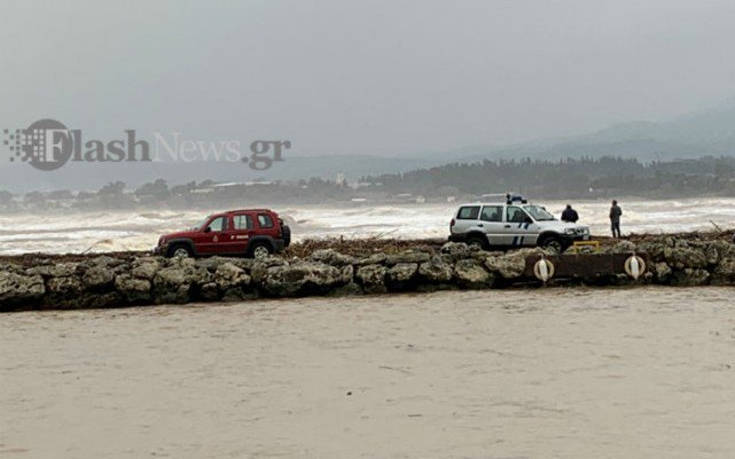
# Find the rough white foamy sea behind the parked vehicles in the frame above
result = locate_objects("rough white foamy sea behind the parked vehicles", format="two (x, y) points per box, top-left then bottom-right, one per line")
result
(0, 198), (735, 255)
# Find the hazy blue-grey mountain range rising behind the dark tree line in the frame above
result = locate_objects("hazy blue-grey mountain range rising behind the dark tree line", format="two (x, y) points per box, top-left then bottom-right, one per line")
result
(5, 99), (735, 192)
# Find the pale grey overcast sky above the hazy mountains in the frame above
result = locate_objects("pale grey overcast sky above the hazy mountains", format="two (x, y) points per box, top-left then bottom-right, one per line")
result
(0, 0), (735, 155)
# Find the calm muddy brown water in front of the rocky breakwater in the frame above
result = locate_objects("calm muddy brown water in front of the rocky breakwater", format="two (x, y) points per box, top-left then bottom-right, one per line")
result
(0, 287), (735, 458)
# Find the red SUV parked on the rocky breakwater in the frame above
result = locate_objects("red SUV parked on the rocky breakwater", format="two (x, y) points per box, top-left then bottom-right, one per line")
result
(153, 209), (291, 258)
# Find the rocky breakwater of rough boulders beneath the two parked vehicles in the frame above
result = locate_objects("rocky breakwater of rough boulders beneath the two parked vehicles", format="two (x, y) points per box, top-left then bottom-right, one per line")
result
(0, 237), (735, 311)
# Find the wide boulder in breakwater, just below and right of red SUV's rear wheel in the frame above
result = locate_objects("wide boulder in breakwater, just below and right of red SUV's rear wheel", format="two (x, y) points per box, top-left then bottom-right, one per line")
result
(262, 261), (352, 296)
